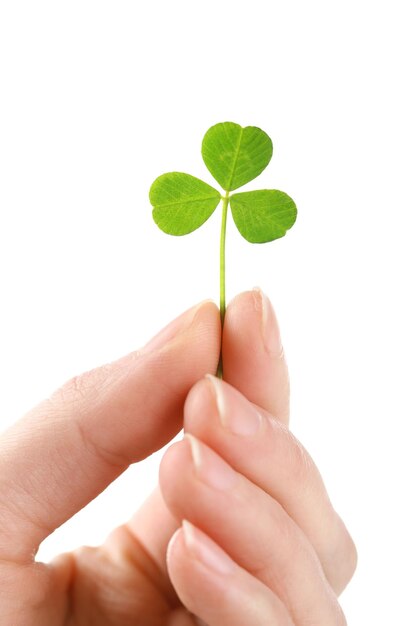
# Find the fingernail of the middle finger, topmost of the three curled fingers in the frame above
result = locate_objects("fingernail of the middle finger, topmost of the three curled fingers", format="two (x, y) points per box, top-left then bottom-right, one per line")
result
(206, 374), (262, 437)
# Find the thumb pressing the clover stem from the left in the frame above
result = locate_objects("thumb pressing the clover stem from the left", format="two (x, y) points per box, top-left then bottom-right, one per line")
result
(0, 302), (220, 562)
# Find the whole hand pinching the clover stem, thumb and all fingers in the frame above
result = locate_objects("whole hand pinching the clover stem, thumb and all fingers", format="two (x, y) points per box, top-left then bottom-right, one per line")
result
(0, 290), (356, 626)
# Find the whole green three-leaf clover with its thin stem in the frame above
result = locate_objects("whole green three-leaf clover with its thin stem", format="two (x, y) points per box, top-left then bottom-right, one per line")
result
(149, 122), (297, 370)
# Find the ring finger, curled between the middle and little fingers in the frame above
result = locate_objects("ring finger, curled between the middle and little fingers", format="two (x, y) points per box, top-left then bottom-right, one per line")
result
(160, 435), (345, 626)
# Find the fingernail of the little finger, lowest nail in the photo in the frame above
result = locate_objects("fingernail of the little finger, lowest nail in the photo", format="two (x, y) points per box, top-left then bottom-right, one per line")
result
(182, 520), (234, 574)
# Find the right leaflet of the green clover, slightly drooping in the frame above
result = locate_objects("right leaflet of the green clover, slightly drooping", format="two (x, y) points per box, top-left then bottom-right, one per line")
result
(230, 189), (297, 243)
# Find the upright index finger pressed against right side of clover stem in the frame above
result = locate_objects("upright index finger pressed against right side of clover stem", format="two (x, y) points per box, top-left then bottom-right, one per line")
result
(222, 289), (289, 424)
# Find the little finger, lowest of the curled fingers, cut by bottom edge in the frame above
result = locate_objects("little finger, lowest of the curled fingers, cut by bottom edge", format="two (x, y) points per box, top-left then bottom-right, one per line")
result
(167, 521), (294, 626)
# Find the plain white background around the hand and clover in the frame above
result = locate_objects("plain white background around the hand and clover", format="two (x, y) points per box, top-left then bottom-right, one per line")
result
(0, 0), (417, 626)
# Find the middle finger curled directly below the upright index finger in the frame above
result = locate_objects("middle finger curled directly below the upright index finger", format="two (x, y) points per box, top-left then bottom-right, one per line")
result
(184, 377), (356, 593)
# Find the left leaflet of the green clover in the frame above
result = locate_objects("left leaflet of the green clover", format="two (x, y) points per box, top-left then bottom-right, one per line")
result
(149, 172), (221, 235)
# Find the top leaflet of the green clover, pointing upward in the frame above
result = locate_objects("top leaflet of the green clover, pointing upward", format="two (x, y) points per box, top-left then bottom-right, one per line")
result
(201, 122), (272, 191)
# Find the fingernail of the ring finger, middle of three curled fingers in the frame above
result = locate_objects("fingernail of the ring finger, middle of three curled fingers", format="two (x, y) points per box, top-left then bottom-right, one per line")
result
(184, 433), (237, 491)
